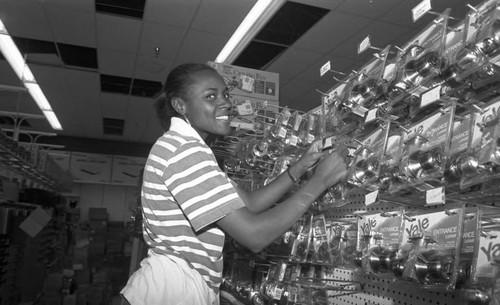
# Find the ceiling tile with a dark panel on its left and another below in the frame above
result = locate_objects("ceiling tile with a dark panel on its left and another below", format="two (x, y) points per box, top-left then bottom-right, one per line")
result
(97, 48), (136, 77)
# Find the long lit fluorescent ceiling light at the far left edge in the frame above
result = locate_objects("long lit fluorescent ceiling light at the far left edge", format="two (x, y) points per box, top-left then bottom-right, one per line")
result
(0, 19), (62, 130)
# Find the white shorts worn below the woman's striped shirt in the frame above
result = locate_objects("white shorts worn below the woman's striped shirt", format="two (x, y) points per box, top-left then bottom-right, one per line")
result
(120, 250), (219, 305)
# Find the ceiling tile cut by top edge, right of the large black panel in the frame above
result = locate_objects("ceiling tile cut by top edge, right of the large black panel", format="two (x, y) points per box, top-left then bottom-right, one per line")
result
(337, 0), (401, 18)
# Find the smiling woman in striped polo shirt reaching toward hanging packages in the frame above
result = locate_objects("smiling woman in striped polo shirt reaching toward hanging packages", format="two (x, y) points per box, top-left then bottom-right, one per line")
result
(122, 64), (346, 305)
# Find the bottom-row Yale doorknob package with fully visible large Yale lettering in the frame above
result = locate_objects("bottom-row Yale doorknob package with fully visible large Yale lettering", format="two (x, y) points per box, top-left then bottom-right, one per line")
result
(402, 208), (463, 290)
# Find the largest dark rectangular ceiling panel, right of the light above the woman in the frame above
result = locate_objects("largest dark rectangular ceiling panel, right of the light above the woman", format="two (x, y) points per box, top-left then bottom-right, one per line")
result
(233, 1), (329, 69)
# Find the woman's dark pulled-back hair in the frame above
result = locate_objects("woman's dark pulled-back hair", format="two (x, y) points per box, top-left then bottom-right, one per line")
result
(155, 63), (217, 131)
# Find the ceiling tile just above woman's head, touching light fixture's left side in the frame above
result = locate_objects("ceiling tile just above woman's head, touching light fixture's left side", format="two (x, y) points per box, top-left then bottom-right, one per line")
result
(176, 31), (229, 63)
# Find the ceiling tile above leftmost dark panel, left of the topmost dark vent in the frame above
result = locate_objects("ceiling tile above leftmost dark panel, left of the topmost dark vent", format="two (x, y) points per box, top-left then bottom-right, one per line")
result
(46, 7), (96, 47)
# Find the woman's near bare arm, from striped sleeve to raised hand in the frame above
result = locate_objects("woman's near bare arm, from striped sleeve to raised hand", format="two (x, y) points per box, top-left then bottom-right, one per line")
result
(218, 153), (347, 252)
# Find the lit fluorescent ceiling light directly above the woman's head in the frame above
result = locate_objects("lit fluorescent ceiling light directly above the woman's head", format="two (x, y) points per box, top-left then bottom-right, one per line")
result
(215, 0), (285, 64)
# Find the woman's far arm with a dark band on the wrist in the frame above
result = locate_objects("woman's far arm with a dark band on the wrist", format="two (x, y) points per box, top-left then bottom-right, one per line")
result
(237, 141), (328, 213)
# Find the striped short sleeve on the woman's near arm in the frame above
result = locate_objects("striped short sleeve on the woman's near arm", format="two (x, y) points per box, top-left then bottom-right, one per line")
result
(163, 141), (245, 231)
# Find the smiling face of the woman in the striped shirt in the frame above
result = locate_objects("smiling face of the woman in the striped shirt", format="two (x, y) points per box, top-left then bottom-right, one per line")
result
(183, 70), (232, 139)
